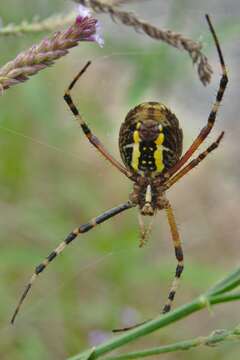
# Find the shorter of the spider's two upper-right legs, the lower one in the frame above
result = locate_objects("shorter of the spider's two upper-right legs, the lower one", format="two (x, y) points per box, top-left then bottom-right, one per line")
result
(166, 132), (224, 190)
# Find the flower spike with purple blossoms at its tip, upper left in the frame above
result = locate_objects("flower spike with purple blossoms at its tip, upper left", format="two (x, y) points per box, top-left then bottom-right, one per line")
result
(0, 10), (103, 91)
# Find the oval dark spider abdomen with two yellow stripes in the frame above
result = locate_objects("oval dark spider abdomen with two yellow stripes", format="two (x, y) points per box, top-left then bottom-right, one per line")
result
(119, 102), (183, 176)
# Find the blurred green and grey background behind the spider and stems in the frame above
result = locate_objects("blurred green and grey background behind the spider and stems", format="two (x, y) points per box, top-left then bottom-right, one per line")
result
(0, 0), (240, 360)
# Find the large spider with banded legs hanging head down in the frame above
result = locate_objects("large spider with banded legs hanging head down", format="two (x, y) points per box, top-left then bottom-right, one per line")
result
(11, 15), (228, 330)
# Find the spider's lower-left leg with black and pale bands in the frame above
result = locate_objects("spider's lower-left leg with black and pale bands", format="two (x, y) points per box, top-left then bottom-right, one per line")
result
(11, 201), (135, 324)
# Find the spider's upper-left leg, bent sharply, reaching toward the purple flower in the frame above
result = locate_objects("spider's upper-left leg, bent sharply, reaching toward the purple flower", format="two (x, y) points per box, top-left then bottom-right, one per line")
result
(63, 61), (132, 178)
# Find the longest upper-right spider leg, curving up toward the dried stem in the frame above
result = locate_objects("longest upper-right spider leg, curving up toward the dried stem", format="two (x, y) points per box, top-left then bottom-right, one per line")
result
(166, 15), (228, 177)
